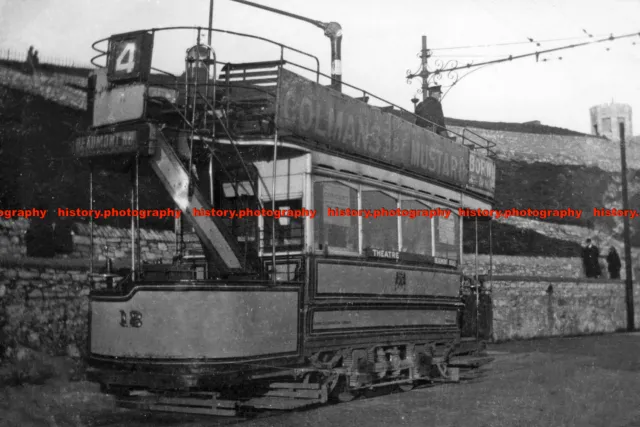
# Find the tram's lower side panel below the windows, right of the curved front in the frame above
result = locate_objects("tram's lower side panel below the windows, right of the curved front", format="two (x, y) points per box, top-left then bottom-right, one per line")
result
(305, 257), (461, 356)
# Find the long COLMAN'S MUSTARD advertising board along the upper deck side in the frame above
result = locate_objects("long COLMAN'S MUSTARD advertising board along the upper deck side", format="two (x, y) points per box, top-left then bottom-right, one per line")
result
(278, 70), (495, 197)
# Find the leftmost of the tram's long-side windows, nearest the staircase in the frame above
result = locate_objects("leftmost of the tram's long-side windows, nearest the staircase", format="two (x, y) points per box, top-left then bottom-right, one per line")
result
(314, 182), (358, 252)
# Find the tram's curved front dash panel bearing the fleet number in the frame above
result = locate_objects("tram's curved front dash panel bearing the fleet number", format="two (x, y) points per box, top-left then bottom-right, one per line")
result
(89, 283), (302, 382)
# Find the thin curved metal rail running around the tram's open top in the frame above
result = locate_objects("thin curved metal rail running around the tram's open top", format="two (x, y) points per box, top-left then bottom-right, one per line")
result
(91, 26), (496, 158)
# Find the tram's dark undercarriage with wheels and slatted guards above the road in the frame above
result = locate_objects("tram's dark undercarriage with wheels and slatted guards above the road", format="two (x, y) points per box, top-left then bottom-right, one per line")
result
(95, 340), (492, 416)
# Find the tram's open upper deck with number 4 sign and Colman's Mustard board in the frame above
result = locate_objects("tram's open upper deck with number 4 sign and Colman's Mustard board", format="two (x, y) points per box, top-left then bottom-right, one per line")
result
(75, 29), (495, 197)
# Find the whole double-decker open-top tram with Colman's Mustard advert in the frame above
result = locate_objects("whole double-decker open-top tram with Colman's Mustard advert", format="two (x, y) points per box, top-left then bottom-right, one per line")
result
(72, 16), (495, 414)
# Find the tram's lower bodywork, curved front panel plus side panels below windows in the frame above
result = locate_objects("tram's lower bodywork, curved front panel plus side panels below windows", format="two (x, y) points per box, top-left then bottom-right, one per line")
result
(90, 257), (461, 388)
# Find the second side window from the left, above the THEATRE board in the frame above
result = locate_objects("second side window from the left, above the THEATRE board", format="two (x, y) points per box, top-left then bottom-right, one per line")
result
(362, 191), (398, 251)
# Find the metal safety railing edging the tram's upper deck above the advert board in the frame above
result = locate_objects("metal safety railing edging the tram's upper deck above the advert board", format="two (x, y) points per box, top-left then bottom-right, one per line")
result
(91, 26), (496, 158)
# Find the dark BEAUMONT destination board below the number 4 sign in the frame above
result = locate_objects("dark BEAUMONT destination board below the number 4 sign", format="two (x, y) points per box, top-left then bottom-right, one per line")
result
(71, 126), (152, 157)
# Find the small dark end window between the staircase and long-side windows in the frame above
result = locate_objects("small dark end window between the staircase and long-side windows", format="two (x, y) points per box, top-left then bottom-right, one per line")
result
(263, 199), (304, 252)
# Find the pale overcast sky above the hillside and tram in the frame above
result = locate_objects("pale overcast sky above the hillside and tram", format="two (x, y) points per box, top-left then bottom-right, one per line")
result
(0, 0), (640, 134)
